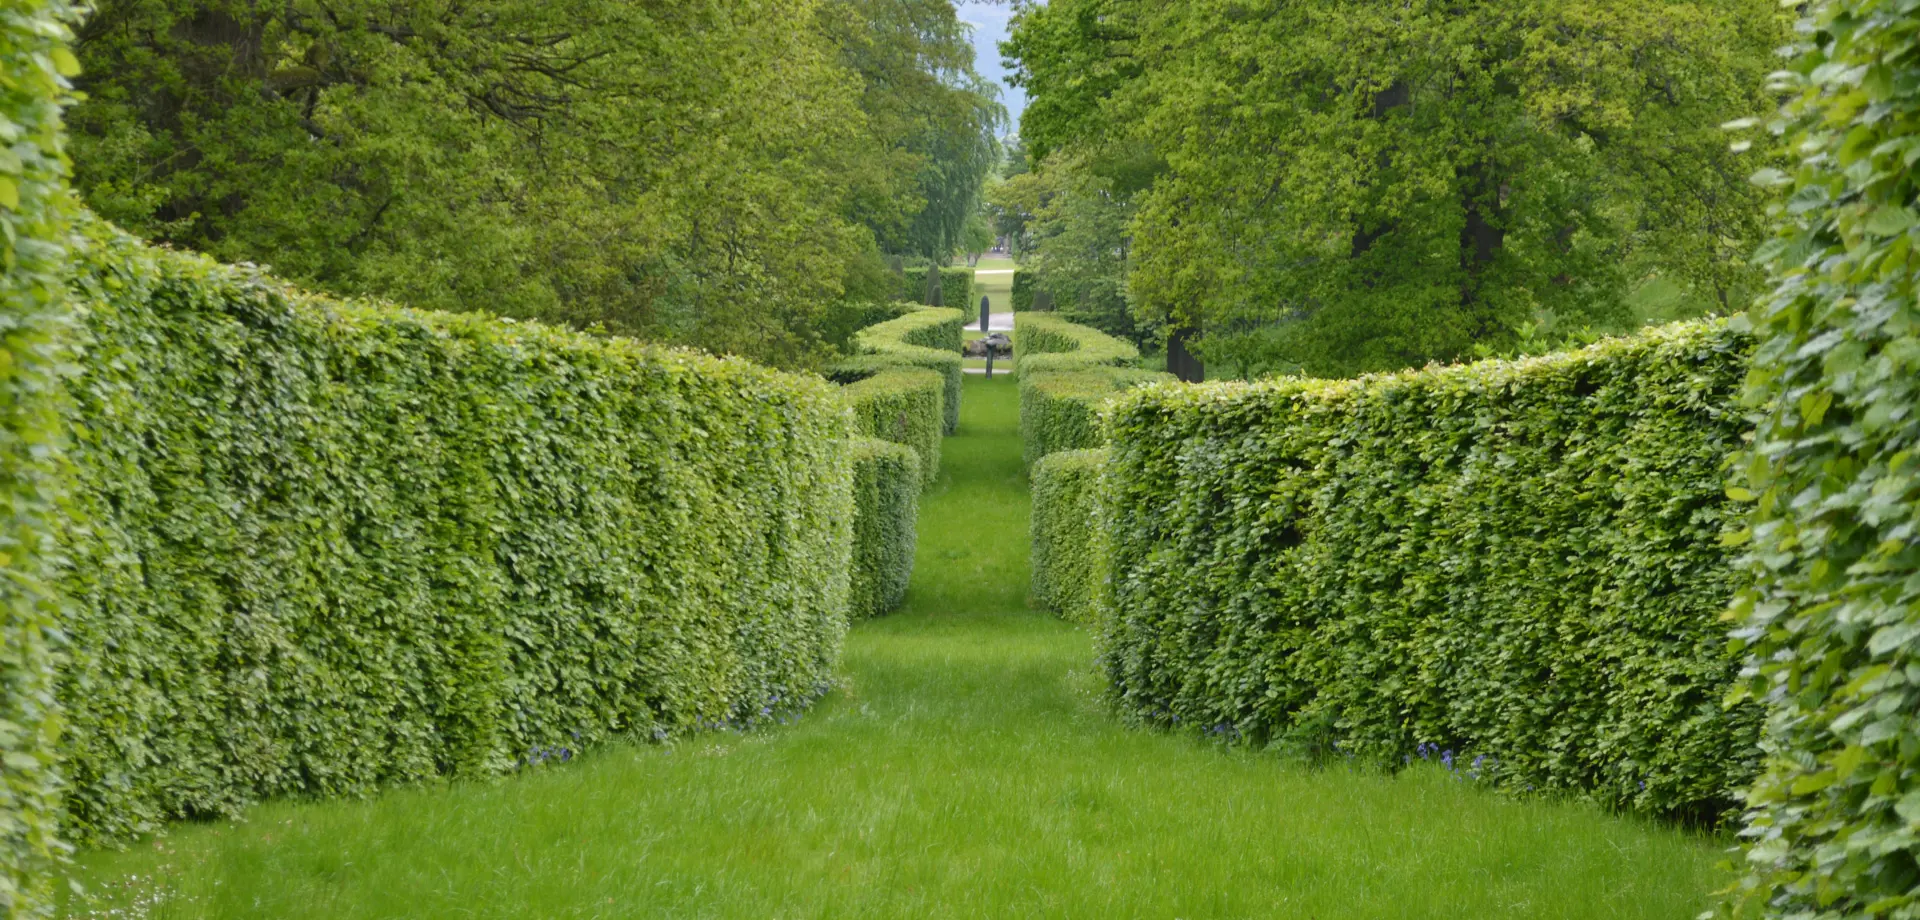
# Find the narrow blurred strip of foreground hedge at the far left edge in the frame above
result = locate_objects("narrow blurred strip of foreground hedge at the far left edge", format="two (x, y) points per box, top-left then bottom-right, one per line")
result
(0, 0), (79, 920)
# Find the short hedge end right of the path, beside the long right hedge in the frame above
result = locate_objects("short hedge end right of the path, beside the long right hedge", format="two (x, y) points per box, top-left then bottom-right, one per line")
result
(1029, 449), (1106, 622)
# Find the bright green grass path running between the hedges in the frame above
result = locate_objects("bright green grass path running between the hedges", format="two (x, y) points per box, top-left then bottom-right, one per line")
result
(73, 378), (1724, 920)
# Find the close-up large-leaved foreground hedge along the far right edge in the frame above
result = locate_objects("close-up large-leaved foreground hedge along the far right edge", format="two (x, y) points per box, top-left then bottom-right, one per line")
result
(1732, 0), (1920, 920)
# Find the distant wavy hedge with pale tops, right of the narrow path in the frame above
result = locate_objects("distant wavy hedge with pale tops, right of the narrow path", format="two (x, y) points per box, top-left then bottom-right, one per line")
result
(1014, 313), (1171, 465)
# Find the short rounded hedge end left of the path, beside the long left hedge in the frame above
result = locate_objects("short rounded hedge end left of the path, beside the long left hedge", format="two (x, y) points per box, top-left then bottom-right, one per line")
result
(847, 438), (922, 618)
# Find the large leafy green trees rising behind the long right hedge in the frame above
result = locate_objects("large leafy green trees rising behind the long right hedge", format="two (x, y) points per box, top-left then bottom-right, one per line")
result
(989, 0), (1793, 376)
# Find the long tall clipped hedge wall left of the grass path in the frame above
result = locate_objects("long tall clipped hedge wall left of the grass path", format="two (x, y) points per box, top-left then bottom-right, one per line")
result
(60, 229), (854, 843)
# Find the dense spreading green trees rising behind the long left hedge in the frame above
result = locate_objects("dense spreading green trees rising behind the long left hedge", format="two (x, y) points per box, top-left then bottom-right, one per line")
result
(69, 0), (1004, 367)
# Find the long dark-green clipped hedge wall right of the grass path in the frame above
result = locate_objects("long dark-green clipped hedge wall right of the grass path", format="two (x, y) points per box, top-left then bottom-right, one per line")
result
(1102, 325), (1759, 820)
